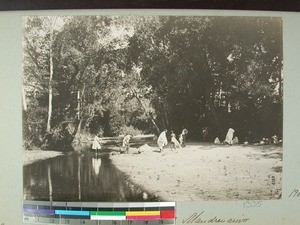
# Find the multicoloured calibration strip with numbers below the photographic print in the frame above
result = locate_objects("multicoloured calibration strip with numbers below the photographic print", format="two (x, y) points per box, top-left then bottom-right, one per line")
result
(23, 200), (175, 224)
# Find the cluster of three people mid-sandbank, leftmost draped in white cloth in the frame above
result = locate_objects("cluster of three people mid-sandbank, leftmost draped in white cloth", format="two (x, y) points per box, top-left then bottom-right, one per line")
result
(157, 129), (188, 151)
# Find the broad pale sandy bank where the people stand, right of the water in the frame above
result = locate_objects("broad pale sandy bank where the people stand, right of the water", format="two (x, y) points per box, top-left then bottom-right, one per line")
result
(111, 143), (282, 201)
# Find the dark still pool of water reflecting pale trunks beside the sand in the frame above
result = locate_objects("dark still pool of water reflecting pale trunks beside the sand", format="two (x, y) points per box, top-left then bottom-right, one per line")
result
(23, 152), (159, 202)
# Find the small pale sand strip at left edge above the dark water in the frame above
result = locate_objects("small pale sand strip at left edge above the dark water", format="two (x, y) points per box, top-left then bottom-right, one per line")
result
(23, 150), (62, 166)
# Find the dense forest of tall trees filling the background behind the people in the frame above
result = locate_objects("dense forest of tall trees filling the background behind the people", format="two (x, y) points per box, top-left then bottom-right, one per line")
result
(22, 16), (283, 149)
